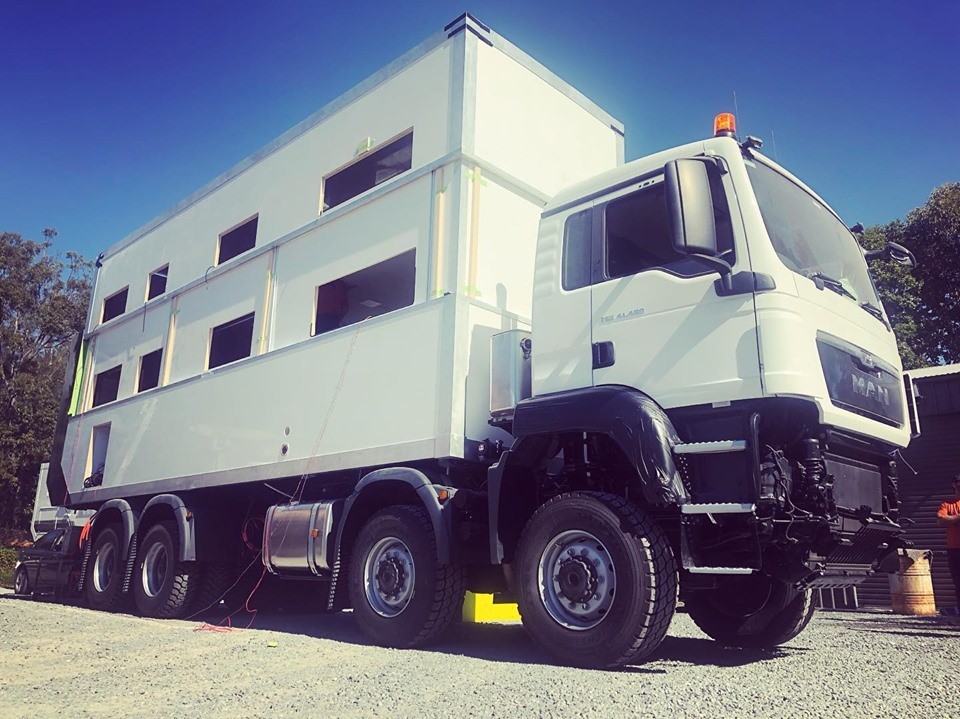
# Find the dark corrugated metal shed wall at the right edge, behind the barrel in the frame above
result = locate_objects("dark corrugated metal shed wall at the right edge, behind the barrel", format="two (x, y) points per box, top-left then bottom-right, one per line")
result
(858, 375), (960, 608)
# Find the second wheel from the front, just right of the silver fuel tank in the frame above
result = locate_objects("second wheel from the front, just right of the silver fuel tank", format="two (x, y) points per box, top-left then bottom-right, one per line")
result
(349, 505), (466, 648)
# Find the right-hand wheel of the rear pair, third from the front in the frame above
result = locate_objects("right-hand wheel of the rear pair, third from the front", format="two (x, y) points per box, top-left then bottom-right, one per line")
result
(132, 522), (200, 619)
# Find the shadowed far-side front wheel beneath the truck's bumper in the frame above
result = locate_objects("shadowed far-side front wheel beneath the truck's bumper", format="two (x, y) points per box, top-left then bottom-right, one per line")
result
(684, 573), (814, 649)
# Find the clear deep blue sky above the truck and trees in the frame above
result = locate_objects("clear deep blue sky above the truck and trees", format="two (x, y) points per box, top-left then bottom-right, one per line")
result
(0, 0), (960, 257)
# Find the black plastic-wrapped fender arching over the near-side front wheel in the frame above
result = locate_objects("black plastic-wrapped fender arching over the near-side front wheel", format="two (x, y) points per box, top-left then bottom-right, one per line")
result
(487, 385), (689, 564)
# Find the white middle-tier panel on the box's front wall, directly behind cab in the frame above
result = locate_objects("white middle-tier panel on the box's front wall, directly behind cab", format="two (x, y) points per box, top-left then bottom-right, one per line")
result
(471, 173), (540, 317)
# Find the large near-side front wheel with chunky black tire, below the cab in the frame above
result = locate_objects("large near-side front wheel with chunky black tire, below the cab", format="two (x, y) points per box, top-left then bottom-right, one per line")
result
(516, 492), (677, 668)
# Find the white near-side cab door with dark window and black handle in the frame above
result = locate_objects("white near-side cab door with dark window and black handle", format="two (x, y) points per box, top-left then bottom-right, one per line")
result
(592, 165), (760, 409)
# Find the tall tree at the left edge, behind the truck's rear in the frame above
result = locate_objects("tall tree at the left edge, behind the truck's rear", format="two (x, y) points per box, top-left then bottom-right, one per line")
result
(0, 229), (91, 527)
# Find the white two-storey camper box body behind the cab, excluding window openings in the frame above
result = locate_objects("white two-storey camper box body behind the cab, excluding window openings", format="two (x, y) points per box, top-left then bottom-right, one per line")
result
(62, 21), (622, 502)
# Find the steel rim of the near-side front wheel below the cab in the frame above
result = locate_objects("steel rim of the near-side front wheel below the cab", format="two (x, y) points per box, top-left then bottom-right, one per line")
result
(537, 529), (617, 631)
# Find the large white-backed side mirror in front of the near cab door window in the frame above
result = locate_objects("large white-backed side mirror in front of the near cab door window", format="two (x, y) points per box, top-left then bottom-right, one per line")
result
(663, 158), (731, 277)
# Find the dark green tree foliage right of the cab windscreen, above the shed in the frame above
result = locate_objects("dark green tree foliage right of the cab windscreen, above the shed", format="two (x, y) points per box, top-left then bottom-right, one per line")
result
(862, 182), (960, 369)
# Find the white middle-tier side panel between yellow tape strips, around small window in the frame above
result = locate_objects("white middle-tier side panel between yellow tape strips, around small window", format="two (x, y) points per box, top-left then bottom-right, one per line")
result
(169, 255), (270, 383)
